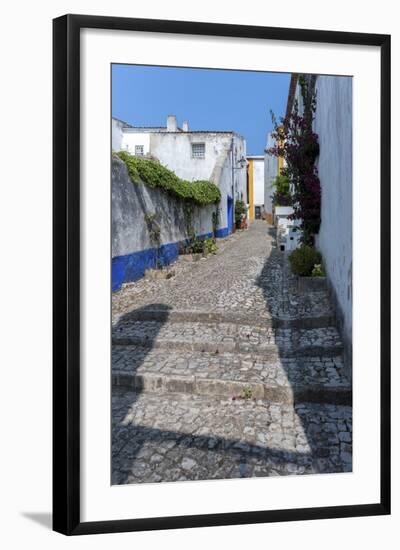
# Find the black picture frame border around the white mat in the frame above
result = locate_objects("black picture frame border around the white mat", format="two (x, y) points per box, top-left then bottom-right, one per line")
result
(53, 15), (390, 535)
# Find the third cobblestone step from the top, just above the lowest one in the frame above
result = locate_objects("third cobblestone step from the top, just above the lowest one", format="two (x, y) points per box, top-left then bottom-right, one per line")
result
(112, 346), (351, 405)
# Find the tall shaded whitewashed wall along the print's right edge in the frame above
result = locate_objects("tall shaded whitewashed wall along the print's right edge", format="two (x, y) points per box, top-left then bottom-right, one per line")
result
(314, 76), (352, 364)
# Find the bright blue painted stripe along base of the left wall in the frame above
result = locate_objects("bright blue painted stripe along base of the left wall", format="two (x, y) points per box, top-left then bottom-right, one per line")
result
(111, 227), (229, 292)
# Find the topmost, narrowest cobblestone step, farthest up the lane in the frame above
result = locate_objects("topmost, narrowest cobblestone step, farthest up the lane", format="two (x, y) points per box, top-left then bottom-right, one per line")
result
(116, 307), (335, 329)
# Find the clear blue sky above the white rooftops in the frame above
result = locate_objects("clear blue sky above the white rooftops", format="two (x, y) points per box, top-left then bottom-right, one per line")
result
(112, 65), (290, 155)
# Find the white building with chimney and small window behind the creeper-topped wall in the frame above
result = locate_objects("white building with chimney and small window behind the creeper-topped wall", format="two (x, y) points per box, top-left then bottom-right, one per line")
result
(112, 115), (248, 237)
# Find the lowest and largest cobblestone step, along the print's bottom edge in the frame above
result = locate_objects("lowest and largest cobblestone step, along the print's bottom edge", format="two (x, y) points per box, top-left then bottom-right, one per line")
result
(112, 389), (352, 484)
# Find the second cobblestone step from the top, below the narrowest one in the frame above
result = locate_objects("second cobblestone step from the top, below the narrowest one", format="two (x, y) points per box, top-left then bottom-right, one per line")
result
(113, 321), (343, 359)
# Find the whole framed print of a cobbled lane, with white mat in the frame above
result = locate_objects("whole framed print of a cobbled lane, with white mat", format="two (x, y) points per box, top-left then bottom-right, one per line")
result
(53, 15), (390, 535)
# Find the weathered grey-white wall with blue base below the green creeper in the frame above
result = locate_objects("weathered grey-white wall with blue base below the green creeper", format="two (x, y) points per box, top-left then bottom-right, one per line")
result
(112, 157), (219, 291)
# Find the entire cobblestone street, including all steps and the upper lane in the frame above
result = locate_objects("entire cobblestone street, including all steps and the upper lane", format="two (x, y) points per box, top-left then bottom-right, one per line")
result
(112, 221), (352, 484)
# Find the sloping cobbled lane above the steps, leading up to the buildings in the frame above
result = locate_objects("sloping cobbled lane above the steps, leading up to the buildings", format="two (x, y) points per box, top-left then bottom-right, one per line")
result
(112, 222), (334, 323)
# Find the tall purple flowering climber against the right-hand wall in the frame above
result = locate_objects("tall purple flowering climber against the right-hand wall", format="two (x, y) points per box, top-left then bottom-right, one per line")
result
(268, 76), (321, 244)
